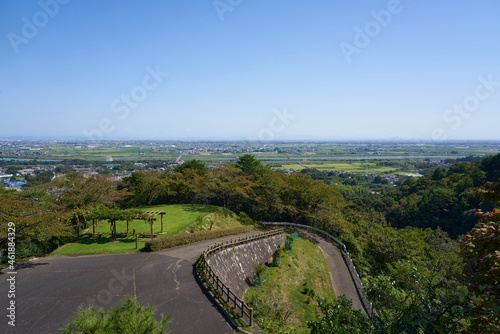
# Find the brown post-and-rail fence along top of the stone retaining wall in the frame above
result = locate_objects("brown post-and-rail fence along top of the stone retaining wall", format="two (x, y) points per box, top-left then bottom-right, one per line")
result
(202, 228), (284, 326)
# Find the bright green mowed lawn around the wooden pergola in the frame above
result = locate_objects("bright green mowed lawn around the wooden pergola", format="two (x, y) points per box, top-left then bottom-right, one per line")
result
(53, 204), (218, 255)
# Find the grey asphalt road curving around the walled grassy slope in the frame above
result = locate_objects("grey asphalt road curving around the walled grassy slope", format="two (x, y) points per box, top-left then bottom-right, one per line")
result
(0, 232), (368, 334)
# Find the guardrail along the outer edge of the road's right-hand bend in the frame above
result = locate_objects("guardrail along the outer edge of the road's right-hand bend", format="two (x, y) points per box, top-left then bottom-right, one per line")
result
(262, 222), (378, 318)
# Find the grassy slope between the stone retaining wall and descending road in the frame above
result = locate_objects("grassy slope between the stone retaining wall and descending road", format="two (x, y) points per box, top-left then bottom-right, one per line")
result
(245, 238), (335, 334)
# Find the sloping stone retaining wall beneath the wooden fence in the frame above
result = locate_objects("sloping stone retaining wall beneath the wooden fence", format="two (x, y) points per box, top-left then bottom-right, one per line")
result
(207, 234), (285, 298)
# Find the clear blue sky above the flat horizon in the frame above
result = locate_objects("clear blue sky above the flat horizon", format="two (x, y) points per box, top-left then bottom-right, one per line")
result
(0, 0), (500, 140)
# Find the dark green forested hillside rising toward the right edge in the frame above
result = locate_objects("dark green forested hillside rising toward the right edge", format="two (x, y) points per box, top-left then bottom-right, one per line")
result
(344, 155), (500, 238)
